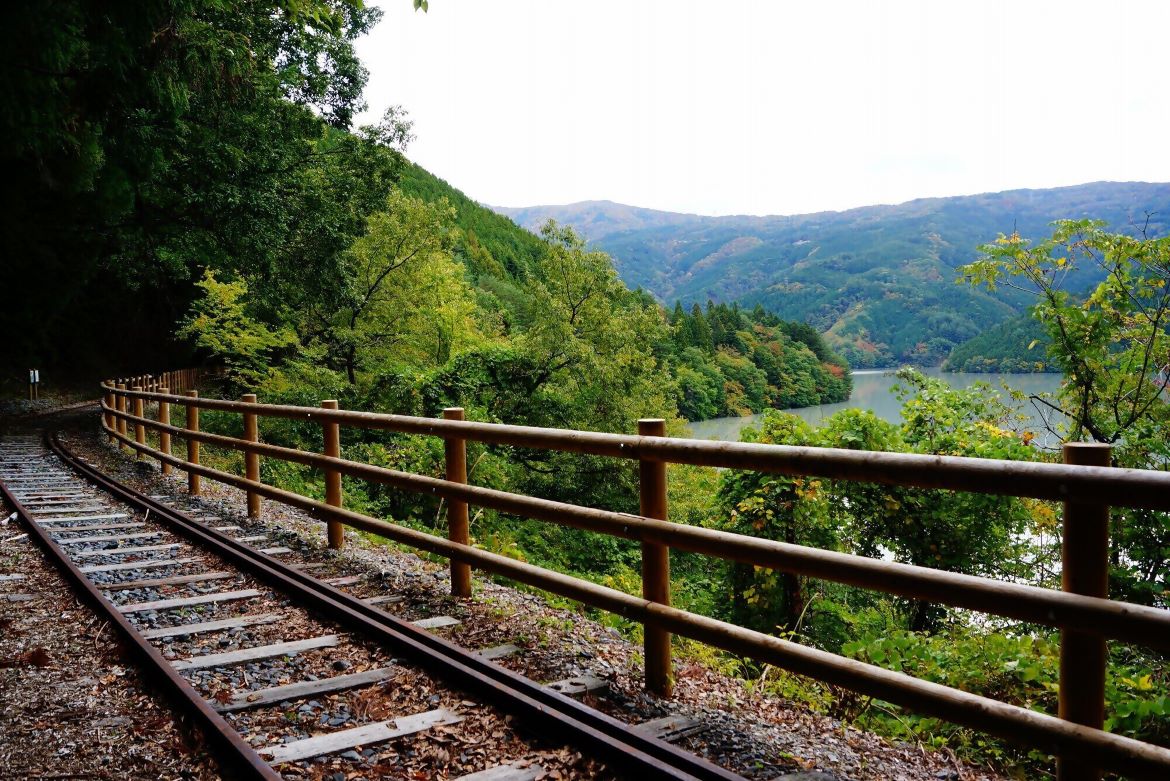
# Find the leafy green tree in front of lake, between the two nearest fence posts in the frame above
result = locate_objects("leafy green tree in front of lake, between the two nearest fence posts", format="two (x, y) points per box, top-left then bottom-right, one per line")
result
(721, 369), (1037, 630)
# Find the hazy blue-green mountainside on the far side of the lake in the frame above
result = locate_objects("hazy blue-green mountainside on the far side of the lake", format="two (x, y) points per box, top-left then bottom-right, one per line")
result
(497, 182), (1170, 367)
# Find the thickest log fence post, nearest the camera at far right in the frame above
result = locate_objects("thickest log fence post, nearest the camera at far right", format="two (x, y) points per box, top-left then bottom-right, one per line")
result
(1057, 442), (1113, 781)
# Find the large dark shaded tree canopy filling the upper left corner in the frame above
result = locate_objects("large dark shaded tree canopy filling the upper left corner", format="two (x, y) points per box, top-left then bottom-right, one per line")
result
(0, 0), (397, 378)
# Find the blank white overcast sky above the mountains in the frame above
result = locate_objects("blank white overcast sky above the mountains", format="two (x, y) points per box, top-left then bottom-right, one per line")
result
(358, 0), (1170, 214)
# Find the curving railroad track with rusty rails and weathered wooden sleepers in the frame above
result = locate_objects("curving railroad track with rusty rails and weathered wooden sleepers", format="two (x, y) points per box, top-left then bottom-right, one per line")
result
(0, 436), (741, 781)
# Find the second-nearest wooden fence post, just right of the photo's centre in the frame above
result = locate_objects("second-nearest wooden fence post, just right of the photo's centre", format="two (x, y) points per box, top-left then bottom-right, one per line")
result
(638, 417), (673, 697)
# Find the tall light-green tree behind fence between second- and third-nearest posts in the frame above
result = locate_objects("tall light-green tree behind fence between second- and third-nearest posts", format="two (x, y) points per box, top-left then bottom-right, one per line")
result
(498, 222), (677, 523)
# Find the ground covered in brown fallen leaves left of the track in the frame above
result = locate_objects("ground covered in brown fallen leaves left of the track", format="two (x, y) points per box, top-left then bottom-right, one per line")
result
(0, 493), (221, 781)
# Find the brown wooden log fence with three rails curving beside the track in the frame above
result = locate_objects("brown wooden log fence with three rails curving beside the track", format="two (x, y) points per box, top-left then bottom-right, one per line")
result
(102, 380), (1170, 780)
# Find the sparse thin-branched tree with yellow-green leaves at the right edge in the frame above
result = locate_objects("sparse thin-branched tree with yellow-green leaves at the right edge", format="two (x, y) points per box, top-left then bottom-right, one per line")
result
(963, 220), (1170, 604)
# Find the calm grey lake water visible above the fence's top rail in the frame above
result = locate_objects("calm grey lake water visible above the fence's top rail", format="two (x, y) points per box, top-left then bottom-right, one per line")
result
(690, 368), (1060, 442)
